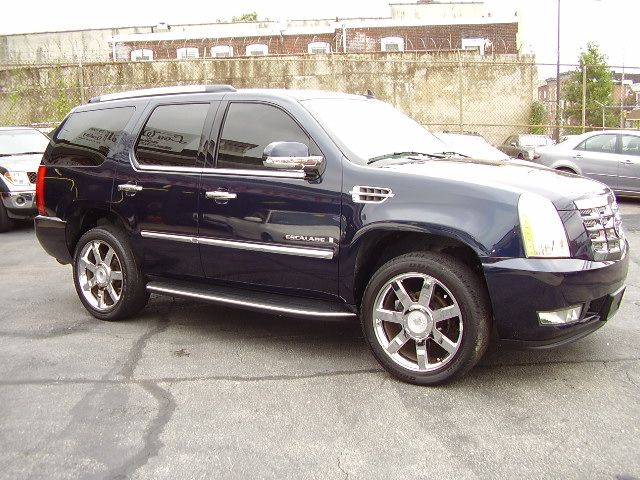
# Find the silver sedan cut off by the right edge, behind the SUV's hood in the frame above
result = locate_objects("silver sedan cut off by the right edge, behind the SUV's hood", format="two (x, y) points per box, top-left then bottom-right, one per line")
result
(536, 130), (640, 196)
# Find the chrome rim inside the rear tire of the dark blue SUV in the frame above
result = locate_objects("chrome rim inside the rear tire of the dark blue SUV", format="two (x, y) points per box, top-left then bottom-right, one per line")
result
(76, 240), (123, 312)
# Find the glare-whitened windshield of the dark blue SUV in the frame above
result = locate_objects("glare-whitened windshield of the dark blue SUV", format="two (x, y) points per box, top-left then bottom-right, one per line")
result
(302, 98), (447, 164)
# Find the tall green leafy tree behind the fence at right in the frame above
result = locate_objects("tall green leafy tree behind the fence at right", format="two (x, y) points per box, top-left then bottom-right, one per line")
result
(561, 42), (618, 129)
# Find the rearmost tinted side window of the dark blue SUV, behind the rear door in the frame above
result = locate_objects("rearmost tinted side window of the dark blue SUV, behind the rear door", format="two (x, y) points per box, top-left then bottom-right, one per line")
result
(45, 107), (135, 167)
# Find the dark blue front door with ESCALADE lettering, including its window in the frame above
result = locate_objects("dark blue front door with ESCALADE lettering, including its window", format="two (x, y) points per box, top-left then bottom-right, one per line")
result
(198, 102), (341, 295)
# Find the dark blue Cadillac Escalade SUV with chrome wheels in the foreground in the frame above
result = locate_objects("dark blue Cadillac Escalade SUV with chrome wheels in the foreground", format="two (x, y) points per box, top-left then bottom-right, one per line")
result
(35, 86), (628, 384)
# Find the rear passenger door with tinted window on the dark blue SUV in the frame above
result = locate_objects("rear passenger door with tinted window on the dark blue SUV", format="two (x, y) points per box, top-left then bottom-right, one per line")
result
(113, 101), (217, 278)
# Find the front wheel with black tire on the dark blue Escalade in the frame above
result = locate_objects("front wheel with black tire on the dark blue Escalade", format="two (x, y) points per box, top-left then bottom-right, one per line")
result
(360, 252), (491, 385)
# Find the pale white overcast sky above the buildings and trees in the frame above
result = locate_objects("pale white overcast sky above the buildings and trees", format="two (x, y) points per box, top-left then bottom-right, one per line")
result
(0, 0), (640, 73)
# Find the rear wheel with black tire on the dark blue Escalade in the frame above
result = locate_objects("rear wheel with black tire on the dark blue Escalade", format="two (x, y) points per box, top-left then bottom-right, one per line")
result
(73, 225), (149, 321)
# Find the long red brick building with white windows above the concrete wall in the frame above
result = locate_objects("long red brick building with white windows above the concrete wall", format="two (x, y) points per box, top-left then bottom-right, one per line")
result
(110, 17), (518, 61)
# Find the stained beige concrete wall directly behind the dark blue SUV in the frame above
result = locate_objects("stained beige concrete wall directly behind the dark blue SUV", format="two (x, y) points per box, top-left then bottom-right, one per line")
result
(0, 52), (537, 142)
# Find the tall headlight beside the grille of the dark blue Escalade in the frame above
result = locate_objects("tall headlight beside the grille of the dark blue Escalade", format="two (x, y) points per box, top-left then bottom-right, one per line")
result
(518, 193), (570, 258)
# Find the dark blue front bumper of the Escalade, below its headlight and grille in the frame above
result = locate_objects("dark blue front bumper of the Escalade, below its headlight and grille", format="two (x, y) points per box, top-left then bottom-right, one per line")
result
(483, 254), (629, 348)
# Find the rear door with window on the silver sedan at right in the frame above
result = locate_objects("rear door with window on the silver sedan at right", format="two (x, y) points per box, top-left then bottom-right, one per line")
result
(571, 133), (620, 189)
